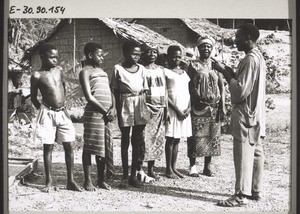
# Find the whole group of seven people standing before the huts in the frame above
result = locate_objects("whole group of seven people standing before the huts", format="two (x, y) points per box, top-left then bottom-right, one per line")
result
(31, 24), (265, 206)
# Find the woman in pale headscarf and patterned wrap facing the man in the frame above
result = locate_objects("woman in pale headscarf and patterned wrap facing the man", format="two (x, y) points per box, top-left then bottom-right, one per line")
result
(187, 37), (225, 177)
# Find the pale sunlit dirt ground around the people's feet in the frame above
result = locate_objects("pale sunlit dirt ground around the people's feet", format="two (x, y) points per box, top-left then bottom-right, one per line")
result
(9, 94), (291, 213)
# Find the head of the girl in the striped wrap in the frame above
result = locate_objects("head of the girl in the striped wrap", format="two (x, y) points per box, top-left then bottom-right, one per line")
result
(83, 42), (104, 66)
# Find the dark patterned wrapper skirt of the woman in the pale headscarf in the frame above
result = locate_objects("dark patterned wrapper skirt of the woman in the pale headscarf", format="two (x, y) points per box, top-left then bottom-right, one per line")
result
(187, 106), (221, 158)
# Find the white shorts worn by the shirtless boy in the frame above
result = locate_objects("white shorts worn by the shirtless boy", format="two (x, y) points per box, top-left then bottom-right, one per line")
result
(35, 104), (75, 144)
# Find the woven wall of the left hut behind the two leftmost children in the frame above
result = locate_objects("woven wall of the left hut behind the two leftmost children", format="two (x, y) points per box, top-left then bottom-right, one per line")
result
(31, 19), (123, 77)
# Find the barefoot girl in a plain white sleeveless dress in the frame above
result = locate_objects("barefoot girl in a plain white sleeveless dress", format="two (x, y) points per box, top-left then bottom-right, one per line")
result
(165, 46), (192, 178)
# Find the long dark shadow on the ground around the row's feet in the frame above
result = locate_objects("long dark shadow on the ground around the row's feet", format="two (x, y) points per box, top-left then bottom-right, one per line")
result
(20, 163), (230, 203)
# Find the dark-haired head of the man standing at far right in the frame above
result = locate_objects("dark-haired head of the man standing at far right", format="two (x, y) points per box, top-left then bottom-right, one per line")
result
(234, 23), (259, 51)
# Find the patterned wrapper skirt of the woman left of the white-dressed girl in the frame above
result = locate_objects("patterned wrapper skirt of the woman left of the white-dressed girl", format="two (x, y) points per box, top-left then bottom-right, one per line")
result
(144, 107), (165, 161)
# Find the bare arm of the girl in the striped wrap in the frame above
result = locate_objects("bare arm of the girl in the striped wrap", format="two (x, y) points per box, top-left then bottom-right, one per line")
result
(79, 70), (106, 116)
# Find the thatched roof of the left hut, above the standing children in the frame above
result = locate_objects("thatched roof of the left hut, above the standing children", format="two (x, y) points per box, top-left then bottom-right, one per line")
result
(22, 18), (192, 62)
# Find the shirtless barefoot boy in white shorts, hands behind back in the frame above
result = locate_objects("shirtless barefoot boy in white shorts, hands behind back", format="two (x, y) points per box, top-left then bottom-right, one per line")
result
(30, 43), (81, 192)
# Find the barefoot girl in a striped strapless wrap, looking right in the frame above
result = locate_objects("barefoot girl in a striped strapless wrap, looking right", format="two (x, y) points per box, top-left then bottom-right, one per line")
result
(79, 42), (116, 191)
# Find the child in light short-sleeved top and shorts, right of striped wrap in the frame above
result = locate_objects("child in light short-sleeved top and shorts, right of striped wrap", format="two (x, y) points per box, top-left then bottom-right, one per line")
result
(111, 41), (150, 187)
